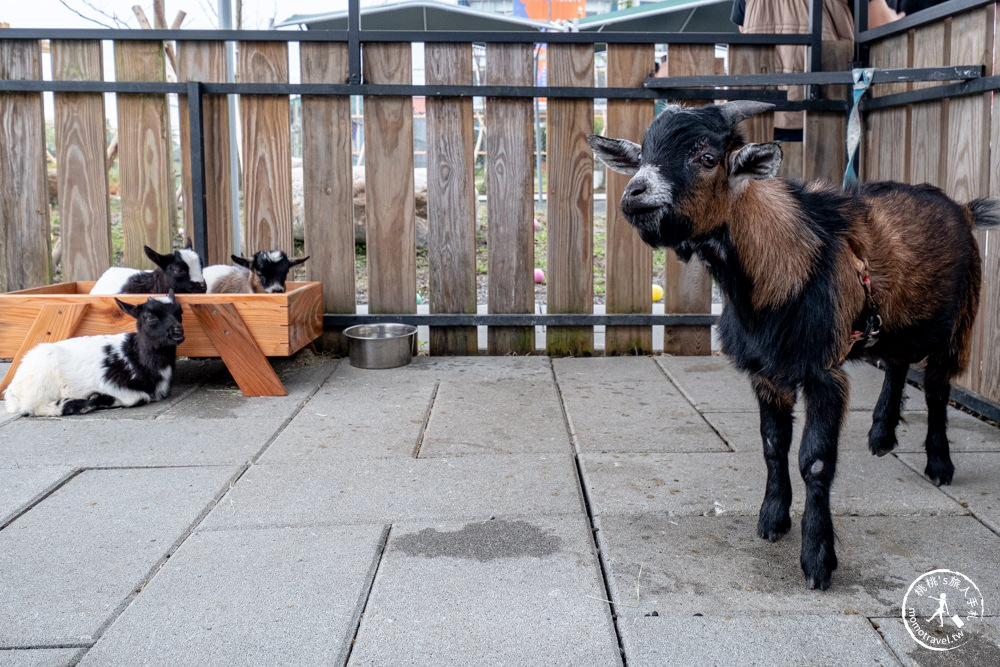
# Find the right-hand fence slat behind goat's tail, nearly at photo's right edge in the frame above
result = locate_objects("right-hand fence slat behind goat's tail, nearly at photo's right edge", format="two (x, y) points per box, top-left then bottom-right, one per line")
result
(945, 6), (997, 391)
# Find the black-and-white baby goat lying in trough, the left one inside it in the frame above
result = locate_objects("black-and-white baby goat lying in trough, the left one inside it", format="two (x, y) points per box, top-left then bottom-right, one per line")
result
(90, 239), (205, 294)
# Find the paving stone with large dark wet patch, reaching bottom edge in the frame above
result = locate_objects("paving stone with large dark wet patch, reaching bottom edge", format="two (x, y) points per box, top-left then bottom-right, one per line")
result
(350, 515), (621, 665)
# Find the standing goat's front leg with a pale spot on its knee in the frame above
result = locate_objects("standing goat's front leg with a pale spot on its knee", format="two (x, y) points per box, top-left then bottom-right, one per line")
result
(799, 368), (848, 590)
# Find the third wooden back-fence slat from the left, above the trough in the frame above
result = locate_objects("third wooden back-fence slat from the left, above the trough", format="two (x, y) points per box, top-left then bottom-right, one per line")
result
(115, 41), (177, 269)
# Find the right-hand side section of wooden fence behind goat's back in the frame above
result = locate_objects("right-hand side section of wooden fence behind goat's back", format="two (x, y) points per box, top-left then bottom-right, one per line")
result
(861, 3), (1000, 402)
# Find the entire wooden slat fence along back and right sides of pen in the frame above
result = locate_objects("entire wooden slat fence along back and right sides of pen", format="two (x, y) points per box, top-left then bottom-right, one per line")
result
(0, 5), (1000, 408)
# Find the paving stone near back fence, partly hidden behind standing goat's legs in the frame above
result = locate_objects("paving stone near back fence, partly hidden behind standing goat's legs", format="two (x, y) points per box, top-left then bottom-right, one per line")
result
(656, 356), (925, 412)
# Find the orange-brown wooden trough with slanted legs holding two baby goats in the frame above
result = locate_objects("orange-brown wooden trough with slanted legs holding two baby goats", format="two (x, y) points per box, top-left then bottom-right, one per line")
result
(0, 282), (323, 396)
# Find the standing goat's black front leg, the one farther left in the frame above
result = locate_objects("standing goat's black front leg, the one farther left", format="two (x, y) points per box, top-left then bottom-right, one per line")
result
(752, 377), (795, 542)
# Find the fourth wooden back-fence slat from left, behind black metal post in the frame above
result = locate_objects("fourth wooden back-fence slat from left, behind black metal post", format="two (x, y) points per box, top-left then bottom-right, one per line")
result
(177, 41), (236, 264)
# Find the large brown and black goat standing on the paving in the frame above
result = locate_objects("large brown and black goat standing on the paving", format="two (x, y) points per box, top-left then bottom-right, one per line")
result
(590, 102), (1000, 589)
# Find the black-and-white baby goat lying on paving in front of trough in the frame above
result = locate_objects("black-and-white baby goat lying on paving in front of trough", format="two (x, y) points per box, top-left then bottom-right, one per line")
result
(4, 292), (184, 416)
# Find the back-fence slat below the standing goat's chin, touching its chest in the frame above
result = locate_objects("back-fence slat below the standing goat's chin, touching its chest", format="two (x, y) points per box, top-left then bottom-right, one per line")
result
(663, 44), (715, 355)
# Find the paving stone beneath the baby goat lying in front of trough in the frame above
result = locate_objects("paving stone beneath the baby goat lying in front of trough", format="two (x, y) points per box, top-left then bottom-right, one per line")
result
(0, 365), (332, 468)
